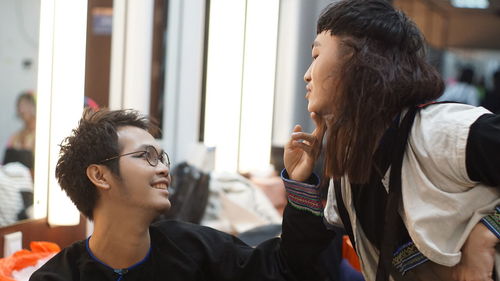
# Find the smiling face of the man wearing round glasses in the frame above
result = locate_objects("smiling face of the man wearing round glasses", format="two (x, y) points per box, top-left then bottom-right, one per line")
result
(109, 126), (170, 214)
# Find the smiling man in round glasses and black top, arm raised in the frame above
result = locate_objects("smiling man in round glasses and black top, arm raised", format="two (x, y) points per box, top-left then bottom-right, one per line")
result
(30, 110), (332, 281)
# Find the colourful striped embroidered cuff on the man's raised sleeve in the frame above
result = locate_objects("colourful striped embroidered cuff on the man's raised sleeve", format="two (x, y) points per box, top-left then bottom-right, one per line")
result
(281, 169), (323, 216)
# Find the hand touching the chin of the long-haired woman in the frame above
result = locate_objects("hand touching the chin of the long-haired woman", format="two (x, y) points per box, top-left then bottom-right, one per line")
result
(283, 112), (326, 181)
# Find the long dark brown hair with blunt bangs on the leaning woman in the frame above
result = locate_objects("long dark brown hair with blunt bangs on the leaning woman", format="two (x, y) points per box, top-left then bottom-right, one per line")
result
(317, 0), (444, 183)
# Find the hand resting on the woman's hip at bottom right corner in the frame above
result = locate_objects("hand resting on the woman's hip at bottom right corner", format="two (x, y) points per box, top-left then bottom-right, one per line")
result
(452, 223), (498, 281)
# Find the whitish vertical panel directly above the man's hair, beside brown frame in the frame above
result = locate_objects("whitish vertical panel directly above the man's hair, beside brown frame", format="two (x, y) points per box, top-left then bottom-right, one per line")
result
(110, 0), (154, 114)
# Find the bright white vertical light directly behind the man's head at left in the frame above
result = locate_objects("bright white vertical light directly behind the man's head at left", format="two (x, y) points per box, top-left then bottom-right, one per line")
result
(35, 0), (87, 226)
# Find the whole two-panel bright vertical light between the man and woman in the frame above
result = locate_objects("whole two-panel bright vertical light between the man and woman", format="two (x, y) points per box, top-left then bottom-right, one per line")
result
(204, 0), (279, 172)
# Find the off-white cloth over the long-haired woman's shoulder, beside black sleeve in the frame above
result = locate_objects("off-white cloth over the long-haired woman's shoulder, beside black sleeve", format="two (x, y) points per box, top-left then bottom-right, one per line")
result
(400, 104), (500, 266)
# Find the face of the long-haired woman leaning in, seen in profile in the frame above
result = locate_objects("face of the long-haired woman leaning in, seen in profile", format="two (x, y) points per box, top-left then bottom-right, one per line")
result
(304, 31), (343, 116)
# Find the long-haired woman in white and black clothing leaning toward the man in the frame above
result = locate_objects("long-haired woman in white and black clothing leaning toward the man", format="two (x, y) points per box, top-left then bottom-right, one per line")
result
(283, 0), (500, 281)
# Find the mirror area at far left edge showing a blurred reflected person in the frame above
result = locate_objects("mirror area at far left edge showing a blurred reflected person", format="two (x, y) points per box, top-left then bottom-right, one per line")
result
(0, 0), (40, 226)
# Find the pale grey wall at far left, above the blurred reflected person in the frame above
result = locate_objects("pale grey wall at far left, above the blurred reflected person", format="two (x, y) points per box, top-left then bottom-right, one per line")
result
(0, 0), (40, 161)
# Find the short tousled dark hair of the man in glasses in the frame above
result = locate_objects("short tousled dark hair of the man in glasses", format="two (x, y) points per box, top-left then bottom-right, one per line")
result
(56, 109), (157, 220)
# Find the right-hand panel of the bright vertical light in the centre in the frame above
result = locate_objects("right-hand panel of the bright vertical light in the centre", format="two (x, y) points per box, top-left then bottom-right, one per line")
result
(239, 0), (279, 172)
